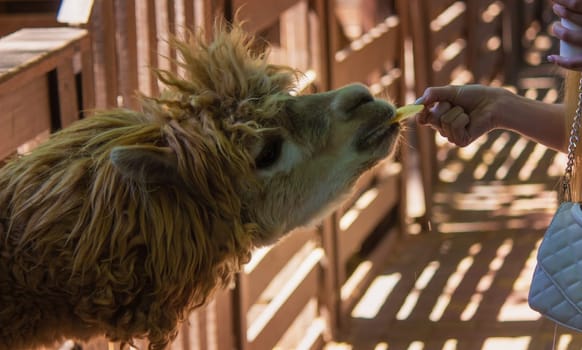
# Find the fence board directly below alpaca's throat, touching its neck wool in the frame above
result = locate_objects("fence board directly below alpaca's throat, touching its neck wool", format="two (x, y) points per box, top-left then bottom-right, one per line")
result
(242, 229), (315, 305)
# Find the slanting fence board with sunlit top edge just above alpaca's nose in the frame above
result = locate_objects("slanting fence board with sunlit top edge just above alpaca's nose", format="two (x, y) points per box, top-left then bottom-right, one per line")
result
(332, 16), (402, 88)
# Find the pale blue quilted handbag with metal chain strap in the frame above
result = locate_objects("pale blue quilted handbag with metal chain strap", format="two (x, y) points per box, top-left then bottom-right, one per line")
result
(528, 75), (582, 332)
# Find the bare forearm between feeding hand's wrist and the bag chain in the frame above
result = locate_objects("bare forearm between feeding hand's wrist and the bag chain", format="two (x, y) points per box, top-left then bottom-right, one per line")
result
(496, 92), (567, 152)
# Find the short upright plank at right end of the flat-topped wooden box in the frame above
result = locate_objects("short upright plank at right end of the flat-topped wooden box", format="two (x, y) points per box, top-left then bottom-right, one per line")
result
(56, 58), (79, 128)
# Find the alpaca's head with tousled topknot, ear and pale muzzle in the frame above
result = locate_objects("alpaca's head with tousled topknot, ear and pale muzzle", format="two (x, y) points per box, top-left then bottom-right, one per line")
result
(111, 25), (399, 245)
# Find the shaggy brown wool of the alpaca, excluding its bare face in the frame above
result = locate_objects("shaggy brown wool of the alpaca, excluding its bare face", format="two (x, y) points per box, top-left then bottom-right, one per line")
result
(0, 22), (294, 349)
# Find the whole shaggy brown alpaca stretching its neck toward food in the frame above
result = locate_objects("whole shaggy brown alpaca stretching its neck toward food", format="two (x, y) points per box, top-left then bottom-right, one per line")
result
(0, 24), (400, 349)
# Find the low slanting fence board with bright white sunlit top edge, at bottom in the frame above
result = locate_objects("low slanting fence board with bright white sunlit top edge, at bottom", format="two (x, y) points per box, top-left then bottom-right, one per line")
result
(247, 249), (324, 349)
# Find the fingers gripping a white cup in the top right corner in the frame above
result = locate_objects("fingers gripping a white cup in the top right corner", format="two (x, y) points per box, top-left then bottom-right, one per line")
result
(548, 0), (582, 71)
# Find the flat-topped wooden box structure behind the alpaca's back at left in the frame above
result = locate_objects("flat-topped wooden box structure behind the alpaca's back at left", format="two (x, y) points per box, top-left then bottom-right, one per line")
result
(0, 28), (94, 160)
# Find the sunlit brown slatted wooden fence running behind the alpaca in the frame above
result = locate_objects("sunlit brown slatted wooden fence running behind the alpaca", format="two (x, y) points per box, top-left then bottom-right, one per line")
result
(0, 0), (556, 350)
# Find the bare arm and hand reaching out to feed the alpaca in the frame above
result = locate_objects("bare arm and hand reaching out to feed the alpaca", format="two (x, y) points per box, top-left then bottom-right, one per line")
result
(417, 85), (566, 152)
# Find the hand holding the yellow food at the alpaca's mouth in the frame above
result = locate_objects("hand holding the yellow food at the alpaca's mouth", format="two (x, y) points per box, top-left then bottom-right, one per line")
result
(417, 85), (507, 147)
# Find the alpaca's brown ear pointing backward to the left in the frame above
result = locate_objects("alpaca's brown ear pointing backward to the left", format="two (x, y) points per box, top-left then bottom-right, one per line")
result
(109, 145), (178, 183)
